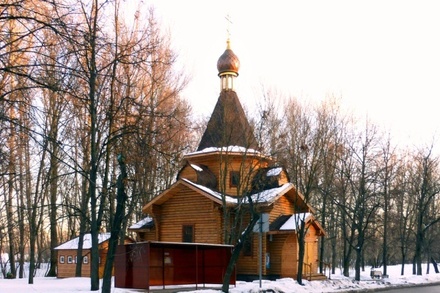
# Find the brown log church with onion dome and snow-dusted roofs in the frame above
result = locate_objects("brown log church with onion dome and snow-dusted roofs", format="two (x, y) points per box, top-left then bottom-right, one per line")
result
(130, 40), (324, 280)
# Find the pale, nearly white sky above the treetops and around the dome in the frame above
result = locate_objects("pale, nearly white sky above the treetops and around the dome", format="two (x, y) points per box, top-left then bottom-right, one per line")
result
(145, 0), (440, 145)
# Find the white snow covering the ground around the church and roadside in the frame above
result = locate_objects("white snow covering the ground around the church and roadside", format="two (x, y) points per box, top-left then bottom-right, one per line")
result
(0, 265), (440, 293)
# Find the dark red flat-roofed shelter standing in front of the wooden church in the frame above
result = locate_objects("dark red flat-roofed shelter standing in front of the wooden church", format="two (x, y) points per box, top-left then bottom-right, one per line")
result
(115, 241), (236, 290)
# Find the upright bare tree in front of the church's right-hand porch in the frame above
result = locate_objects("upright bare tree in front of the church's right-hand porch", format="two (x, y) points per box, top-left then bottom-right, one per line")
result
(284, 99), (335, 284)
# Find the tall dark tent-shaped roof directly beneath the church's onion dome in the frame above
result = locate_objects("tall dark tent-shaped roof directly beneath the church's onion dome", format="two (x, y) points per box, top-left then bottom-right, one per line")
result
(197, 90), (258, 151)
